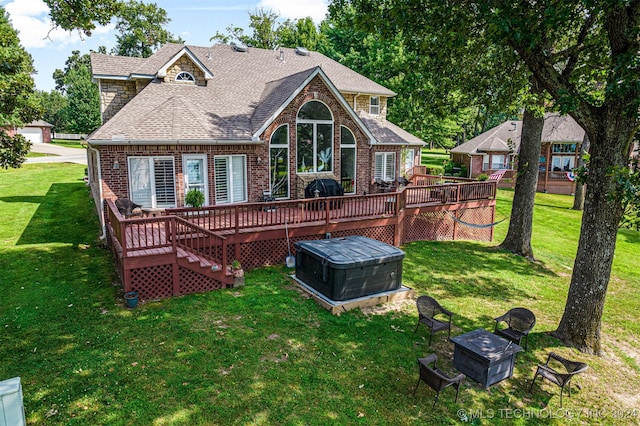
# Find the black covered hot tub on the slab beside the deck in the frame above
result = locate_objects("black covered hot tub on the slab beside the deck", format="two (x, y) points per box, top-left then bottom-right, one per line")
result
(295, 236), (405, 301)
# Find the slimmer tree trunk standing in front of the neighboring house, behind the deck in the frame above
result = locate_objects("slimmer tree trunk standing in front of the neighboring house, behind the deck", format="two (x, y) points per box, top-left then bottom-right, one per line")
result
(499, 95), (544, 260)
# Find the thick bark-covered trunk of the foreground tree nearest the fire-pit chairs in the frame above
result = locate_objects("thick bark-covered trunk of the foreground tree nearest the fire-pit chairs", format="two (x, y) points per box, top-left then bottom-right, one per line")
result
(553, 111), (634, 355)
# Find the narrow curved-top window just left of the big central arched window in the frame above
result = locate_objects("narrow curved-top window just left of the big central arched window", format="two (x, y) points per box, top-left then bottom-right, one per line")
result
(269, 124), (289, 199)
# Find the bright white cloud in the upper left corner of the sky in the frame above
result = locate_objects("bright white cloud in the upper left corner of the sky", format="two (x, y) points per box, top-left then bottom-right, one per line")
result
(5, 0), (112, 49)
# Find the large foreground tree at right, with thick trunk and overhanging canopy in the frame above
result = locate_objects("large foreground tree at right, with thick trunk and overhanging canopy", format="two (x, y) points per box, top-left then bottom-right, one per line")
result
(342, 0), (640, 354)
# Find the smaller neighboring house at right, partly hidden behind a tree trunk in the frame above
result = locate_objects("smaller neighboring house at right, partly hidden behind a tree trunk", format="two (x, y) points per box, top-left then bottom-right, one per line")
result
(451, 114), (584, 195)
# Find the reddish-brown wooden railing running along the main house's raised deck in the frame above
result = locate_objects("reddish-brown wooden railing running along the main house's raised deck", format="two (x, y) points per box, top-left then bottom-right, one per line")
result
(107, 175), (496, 258)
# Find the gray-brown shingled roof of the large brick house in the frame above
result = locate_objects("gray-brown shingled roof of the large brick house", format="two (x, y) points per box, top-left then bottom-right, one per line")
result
(90, 44), (423, 144)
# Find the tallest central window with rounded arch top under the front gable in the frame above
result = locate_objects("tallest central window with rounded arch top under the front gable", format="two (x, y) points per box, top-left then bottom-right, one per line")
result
(296, 101), (333, 173)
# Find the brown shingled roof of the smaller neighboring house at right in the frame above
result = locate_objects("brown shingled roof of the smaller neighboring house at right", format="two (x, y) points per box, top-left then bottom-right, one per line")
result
(451, 113), (584, 154)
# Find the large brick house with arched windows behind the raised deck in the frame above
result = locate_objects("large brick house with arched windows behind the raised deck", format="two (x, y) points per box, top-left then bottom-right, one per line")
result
(87, 44), (424, 226)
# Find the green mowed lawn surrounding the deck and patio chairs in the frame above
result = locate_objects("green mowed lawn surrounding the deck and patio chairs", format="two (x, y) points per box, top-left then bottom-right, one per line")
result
(0, 164), (640, 425)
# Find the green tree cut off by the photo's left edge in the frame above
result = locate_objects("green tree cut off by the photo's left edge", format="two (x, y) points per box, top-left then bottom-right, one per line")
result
(0, 6), (41, 169)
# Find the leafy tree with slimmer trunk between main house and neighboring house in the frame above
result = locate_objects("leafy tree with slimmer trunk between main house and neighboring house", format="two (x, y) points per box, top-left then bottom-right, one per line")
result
(330, 1), (544, 259)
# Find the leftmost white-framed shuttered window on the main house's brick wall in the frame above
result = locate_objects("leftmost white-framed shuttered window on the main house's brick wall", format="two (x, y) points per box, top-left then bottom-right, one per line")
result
(128, 157), (176, 208)
